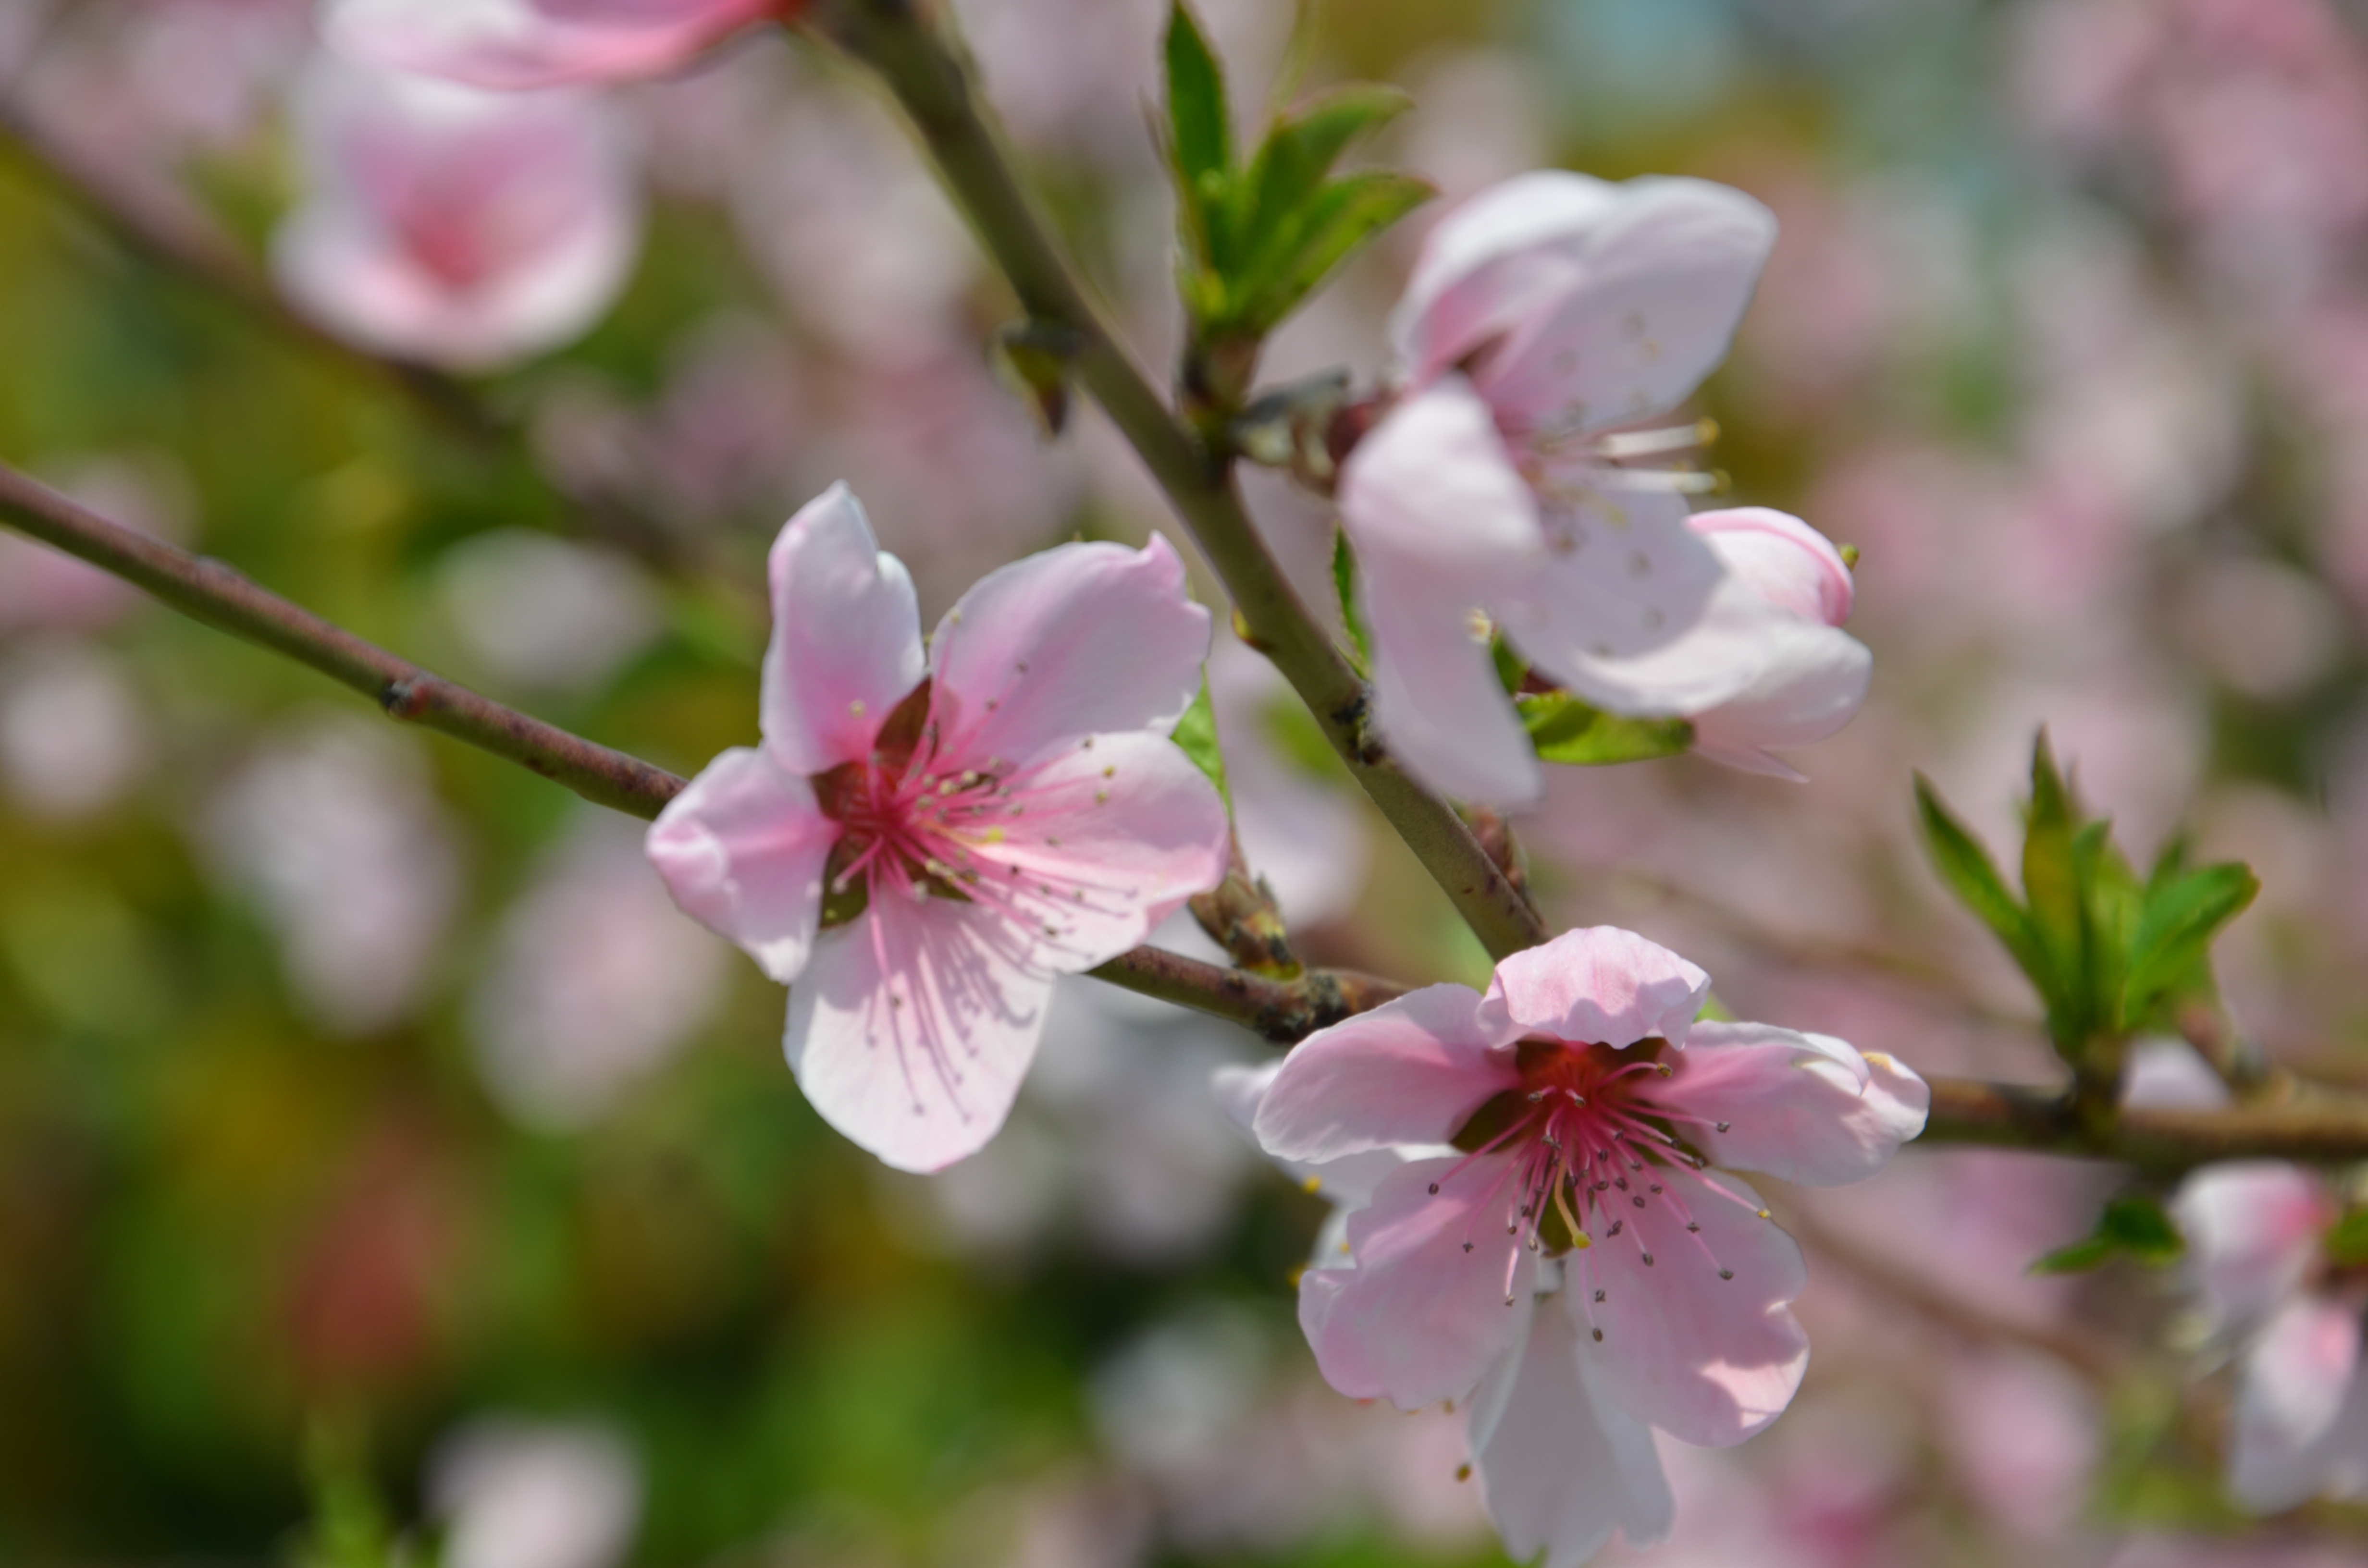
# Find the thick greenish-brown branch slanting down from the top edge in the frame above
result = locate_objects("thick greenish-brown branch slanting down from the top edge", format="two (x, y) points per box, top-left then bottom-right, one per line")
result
(814, 0), (1549, 957)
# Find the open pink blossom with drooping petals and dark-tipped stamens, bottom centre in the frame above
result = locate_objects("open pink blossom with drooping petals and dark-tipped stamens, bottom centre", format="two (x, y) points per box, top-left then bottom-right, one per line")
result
(1233, 926), (1930, 1568)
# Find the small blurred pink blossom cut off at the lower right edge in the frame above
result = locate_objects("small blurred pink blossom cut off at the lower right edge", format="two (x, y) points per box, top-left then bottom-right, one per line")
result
(2171, 1161), (2368, 1514)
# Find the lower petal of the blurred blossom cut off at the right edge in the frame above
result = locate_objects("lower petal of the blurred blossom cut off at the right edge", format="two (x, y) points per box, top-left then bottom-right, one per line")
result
(2228, 1296), (2368, 1514)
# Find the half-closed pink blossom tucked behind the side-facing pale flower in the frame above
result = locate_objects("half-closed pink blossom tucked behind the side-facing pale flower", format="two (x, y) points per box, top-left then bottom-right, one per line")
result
(1691, 507), (1875, 779)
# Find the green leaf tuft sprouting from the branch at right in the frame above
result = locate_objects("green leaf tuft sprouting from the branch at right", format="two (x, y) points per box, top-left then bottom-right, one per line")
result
(1916, 730), (2261, 1068)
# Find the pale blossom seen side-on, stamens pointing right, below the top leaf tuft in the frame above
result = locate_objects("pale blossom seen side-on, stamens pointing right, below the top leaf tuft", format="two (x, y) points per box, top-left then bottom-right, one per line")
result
(1340, 171), (1776, 801)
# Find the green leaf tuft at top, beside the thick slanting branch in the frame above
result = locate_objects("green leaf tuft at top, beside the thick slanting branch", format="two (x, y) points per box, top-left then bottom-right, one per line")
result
(1165, 0), (1435, 374)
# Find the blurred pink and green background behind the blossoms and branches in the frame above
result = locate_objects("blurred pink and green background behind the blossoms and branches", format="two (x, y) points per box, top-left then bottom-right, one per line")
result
(0, 0), (2368, 1568)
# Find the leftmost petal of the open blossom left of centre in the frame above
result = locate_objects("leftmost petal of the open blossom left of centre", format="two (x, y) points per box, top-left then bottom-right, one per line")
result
(644, 746), (839, 985)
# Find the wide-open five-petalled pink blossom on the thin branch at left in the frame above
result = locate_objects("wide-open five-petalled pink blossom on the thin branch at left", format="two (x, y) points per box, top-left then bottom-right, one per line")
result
(649, 486), (1227, 1170)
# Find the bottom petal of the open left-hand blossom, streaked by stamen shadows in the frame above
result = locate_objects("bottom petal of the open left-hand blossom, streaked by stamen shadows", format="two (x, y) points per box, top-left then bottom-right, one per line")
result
(784, 895), (1051, 1170)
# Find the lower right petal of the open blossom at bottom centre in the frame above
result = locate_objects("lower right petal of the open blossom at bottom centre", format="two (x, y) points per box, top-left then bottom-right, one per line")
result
(1565, 1165), (1809, 1447)
